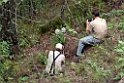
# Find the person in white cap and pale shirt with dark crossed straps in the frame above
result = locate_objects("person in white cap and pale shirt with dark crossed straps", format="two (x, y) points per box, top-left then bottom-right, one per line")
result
(45, 43), (65, 75)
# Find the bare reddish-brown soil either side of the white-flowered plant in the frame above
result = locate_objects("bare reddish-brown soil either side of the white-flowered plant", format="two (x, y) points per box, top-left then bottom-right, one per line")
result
(23, 33), (78, 60)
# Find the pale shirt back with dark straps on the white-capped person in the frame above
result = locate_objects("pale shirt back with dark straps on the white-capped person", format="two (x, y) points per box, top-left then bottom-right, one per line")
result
(45, 44), (65, 74)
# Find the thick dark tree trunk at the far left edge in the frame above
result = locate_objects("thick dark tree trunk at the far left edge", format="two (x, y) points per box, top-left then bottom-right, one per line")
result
(0, 0), (19, 55)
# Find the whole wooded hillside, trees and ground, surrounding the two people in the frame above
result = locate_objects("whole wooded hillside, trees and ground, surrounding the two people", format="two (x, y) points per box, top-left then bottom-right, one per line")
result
(0, 0), (124, 83)
